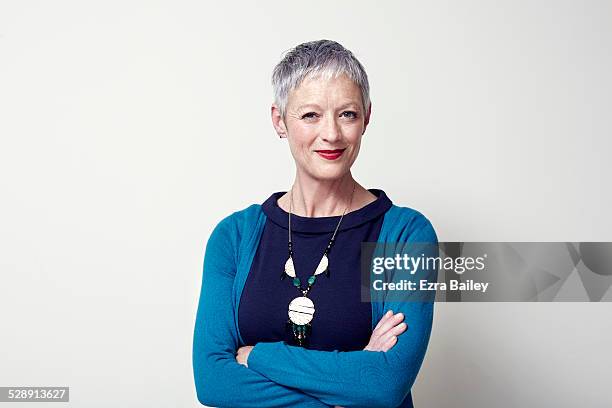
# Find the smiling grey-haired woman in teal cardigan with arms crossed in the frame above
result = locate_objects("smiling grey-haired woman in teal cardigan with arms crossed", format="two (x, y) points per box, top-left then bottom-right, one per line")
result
(193, 40), (437, 407)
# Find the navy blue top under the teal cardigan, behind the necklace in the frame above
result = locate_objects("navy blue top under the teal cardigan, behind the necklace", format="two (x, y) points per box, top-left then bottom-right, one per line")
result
(238, 189), (392, 351)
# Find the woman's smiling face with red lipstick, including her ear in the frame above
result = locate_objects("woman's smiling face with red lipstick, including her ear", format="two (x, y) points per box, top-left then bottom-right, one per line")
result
(272, 74), (369, 180)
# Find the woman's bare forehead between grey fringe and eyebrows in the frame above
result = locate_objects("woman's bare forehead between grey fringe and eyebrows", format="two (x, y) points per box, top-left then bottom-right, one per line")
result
(288, 74), (361, 105)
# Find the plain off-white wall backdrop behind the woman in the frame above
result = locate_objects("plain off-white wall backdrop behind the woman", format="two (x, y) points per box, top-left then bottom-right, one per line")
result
(0, 0), (612, 408)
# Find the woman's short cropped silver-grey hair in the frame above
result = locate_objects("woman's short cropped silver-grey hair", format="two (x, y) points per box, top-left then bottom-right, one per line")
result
(272, 40), (370, 118)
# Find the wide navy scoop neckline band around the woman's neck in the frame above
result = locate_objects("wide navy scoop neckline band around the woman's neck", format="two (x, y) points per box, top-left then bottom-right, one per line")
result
(262, 188), (393, 233)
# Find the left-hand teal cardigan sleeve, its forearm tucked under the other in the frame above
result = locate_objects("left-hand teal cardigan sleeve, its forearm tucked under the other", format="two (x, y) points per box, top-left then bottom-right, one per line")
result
(192, 216), (327, 408)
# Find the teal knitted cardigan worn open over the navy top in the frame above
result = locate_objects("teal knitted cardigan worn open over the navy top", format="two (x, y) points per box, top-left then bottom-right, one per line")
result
(193, 204), (438, 408)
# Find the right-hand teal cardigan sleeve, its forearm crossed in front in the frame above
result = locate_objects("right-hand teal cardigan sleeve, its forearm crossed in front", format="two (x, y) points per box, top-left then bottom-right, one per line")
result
(247, 215), (438, 408)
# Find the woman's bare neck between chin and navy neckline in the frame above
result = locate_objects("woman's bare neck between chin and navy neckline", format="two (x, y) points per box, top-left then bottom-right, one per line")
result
(287, 172), (356, 217)
